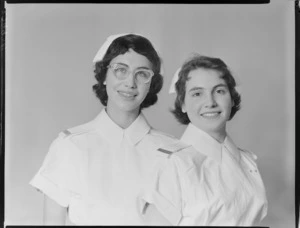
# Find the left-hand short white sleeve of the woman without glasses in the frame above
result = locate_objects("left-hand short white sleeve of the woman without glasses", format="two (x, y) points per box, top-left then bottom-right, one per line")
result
(141, 158), (182, 225)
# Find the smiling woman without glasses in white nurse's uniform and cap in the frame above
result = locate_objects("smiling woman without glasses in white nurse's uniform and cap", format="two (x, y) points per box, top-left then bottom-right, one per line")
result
(144, 55), (267, 226)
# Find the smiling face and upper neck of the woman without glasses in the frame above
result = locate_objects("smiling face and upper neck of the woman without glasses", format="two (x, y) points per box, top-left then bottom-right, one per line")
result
(182, 68), (234, 141)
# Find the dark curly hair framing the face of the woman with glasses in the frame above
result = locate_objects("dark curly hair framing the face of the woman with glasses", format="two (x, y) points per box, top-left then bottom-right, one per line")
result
(93, 34), (163, 110)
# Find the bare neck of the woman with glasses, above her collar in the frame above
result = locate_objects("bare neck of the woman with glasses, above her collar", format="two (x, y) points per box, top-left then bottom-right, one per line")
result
(106, 106), (139, 129)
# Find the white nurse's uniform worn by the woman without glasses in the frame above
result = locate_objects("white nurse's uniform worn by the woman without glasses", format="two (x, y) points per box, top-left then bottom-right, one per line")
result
(143, 124), (267, 226)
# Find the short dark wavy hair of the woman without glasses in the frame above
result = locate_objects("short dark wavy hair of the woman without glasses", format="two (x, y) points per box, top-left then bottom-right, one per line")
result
(171, 54), (241, 124)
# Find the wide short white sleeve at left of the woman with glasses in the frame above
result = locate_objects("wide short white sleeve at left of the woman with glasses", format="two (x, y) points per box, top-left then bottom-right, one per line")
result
(30, 136), (79, 207)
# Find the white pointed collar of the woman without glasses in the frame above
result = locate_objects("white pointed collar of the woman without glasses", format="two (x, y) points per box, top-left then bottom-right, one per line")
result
(181, 123), (240, 162)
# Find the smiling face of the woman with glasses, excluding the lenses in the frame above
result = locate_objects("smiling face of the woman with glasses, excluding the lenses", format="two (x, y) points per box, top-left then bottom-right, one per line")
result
(105, 49), (152, 115)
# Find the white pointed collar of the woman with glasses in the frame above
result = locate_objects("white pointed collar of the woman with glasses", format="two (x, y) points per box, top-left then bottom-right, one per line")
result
(94, 109), (151, 145)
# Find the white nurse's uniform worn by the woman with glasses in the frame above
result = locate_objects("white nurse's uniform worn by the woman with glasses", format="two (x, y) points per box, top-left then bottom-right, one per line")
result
(30, 109), (178, 225)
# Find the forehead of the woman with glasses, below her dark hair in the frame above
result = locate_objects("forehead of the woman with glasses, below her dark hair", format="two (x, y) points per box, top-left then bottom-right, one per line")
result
(111, 49), (152, 68)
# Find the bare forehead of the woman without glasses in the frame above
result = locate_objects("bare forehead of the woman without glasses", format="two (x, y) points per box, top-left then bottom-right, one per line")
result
(186, 68), (227, 90)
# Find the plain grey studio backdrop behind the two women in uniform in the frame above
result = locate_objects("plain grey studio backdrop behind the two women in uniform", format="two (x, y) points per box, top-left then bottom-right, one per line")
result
(5, 0), (295, 228)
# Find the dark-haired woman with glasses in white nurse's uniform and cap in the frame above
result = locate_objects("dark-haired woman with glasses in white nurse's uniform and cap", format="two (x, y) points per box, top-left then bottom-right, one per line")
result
(31, 34), (185, 225)
